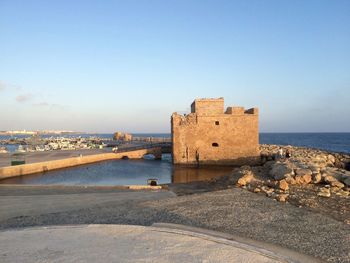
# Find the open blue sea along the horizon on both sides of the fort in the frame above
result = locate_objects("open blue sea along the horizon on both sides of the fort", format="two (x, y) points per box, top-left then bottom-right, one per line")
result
(0, 133), (350, 153)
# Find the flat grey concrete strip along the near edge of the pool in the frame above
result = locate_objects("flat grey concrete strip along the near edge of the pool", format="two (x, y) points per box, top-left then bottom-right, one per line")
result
(0, 187), (176, 225)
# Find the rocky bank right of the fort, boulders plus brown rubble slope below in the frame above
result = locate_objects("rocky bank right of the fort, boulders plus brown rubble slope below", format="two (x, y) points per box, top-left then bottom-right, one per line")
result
(231, 145), (350, 224)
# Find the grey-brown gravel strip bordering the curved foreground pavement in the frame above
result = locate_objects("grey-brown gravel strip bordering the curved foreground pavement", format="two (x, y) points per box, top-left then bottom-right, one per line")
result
(0, 188), (350, 262)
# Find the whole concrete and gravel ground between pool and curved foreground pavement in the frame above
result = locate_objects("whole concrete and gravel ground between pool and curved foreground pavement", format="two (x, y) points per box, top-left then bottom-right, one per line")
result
(0, 186), (350, 262)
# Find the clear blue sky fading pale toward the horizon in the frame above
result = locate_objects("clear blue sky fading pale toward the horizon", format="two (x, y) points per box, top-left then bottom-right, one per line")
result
(0, 0), (350, 132)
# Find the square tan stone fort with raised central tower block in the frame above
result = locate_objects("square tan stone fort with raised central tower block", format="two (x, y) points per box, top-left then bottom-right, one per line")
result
(171, 98), (260, 165)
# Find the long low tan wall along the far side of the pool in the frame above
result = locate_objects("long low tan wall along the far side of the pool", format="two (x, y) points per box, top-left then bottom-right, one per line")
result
(0, 147), (161, 180)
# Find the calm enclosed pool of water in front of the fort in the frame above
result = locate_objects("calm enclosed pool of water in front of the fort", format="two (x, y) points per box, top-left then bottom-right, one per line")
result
(0, 154), (232, 186)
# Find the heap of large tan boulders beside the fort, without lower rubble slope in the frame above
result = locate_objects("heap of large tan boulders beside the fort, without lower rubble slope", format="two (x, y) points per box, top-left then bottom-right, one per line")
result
(233, 145), (350, 202)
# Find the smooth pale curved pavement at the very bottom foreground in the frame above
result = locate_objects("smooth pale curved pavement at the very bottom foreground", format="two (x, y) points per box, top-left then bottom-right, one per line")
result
(0, 225), (316, 263)
